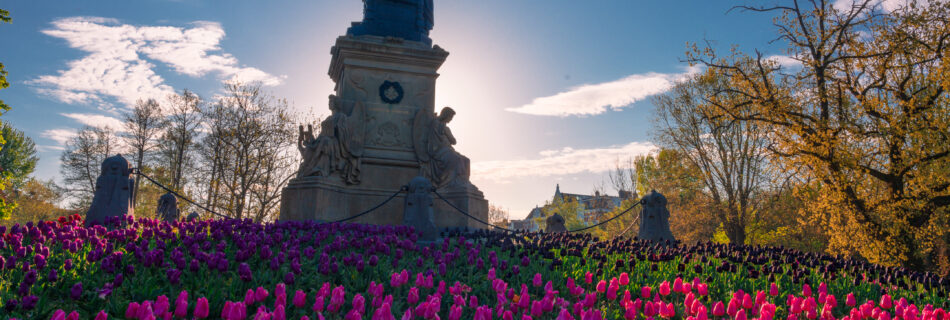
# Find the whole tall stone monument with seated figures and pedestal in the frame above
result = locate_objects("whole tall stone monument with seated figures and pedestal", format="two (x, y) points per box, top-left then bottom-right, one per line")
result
(280, 0), (488, 228)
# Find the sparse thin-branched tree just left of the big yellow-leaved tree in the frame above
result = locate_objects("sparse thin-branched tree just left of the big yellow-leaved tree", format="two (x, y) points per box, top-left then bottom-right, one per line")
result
(653, 71), (780, 244)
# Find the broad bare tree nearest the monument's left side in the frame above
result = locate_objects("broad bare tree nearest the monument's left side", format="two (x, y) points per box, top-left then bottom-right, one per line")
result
(198, 83), (297, 221)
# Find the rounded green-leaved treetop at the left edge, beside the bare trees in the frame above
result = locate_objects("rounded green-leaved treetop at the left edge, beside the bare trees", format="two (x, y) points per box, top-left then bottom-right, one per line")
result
(0, 121), (39, 190)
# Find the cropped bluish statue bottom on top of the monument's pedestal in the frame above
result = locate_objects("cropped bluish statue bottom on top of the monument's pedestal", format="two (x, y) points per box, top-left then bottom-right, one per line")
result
(346, 0), (434, 45)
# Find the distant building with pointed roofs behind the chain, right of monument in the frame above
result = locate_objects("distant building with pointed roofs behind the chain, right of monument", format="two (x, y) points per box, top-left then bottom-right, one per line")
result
(509, 184), (637, 231)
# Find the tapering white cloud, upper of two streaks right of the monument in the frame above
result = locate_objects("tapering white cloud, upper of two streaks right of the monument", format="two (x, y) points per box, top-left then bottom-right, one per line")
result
(506, 67), (699, 117)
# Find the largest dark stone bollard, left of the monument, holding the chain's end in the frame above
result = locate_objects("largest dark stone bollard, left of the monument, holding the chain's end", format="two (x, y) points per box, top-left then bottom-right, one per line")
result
(86, 154), (135, 226)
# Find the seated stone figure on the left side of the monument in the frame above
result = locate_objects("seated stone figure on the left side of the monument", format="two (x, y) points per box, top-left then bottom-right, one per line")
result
(297, 95), (364, 184)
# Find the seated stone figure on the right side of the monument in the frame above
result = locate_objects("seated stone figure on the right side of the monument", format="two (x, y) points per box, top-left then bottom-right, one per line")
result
(413, 107), (471, 188)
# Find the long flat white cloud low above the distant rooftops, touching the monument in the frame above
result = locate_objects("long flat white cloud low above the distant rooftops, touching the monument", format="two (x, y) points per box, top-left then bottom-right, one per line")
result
(472, 142), (656, 183)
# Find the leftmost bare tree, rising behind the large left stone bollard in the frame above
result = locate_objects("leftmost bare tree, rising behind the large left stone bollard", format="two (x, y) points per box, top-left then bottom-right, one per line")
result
(60, 127), (118, 208)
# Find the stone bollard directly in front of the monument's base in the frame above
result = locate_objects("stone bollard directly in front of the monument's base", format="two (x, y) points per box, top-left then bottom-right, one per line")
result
(402, 176), (439, 241)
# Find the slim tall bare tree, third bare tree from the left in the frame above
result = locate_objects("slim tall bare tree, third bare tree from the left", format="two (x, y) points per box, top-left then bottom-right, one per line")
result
(159, 90), (202, 191)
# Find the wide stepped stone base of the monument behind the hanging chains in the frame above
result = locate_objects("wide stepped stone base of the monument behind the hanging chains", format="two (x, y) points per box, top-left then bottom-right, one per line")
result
(279, 159), (488, 229)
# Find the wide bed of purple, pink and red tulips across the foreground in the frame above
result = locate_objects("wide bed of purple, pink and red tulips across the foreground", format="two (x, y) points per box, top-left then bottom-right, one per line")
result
(0, 216), (950, 320)
